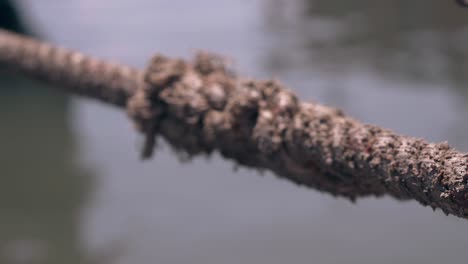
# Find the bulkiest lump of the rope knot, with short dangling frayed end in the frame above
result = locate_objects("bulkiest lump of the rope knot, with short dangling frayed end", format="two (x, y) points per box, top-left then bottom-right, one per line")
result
(127, 52), (232, 158)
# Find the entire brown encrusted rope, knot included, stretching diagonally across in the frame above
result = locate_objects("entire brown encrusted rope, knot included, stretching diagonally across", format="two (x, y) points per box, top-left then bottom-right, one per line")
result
(0, 28), (468, 218)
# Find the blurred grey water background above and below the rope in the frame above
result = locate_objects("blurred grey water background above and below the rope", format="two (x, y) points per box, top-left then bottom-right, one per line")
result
(0, 0), (468, 264)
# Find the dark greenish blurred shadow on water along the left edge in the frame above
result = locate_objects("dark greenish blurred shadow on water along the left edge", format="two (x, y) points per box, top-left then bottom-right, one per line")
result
(0, 0), (114, 264)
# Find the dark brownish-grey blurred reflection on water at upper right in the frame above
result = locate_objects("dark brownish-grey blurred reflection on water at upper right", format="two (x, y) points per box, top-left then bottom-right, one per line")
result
(265, 0), (468, 94)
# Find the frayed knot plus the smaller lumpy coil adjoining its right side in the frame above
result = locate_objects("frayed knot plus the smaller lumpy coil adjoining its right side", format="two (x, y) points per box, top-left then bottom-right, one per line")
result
(127, 52), (299, 158)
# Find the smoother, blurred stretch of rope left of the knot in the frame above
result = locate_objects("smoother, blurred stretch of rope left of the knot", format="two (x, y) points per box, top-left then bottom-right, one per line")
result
(0, 29), (142, 106)
